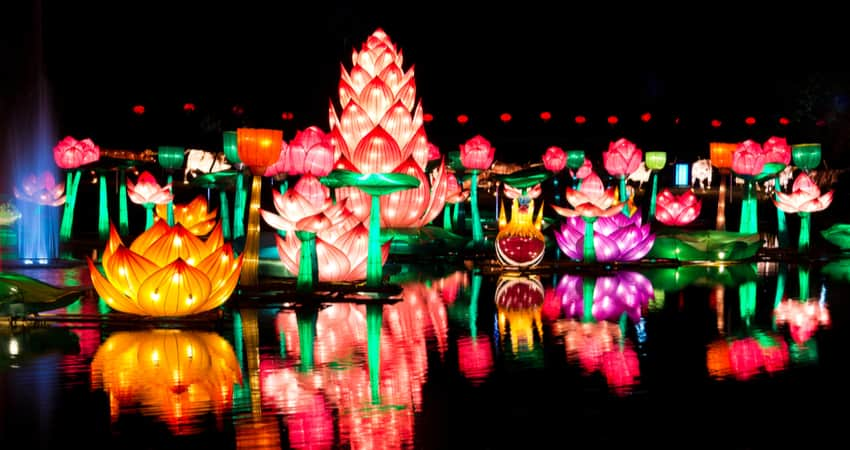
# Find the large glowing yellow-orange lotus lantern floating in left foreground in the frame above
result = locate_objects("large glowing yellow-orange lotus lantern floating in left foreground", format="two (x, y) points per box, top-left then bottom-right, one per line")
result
(86, 220), (242, 317)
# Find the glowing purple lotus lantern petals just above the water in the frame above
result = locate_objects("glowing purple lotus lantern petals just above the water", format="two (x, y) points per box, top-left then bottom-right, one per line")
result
(555, 213), (655, 262)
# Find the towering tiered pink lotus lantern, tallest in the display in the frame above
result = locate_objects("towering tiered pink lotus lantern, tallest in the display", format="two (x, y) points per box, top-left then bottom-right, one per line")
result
(329, 29), (448, 228)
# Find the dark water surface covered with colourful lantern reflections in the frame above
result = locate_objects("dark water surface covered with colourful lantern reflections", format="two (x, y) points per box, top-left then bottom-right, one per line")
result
(0, 261), (850, 450)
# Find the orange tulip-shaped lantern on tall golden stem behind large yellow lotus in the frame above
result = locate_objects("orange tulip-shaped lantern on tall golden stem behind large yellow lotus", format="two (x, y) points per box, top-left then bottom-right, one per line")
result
(236, 128), (283, 285)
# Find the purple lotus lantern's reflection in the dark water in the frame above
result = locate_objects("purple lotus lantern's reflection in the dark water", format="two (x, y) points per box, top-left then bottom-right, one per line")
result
(555, 271), (655, 322)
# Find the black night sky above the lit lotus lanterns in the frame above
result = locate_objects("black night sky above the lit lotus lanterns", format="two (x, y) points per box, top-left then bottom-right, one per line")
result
(0, 0), (850, 190)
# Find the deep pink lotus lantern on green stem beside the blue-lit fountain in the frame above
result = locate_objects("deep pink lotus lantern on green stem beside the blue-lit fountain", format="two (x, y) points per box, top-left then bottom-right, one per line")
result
(53, 136), (100, 242)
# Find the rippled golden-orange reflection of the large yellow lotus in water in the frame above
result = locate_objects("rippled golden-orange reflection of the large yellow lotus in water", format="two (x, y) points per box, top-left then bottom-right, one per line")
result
(91, 330), (242, 434)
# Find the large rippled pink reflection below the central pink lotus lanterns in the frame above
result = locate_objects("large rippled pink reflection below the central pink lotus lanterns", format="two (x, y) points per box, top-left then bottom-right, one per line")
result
(260, 274), (460, 448)
